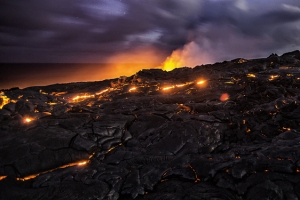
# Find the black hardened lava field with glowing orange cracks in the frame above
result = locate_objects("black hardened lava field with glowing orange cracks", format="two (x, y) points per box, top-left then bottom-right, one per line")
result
(0, 51), (300, 200)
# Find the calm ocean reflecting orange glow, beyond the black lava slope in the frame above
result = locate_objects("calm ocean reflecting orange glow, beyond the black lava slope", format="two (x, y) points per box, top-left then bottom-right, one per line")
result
(0, 63), (159, 89)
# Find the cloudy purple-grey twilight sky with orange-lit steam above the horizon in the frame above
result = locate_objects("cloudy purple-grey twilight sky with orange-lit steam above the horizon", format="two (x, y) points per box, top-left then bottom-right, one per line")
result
(0, 0), (300, 88)
